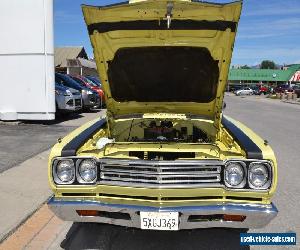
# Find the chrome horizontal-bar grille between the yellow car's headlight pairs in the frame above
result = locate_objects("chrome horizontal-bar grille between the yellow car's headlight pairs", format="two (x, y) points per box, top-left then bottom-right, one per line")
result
(100, 160), (223, 187)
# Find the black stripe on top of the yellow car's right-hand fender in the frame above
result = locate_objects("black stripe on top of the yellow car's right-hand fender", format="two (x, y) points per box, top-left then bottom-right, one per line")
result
(222, 116), (263, 160)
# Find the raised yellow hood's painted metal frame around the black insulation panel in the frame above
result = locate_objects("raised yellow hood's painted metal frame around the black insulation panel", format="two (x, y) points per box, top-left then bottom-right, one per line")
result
(83, 1), (241, 127)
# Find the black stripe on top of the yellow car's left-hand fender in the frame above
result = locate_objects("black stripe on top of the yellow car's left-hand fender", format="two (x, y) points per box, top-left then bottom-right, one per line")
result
(61, 119), (106, 157)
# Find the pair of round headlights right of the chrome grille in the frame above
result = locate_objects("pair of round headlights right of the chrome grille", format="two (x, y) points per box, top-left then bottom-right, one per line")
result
(224, 161), (272, 189)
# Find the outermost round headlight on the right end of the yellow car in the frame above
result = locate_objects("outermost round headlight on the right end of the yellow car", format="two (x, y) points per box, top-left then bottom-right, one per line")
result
(248, 162), (271, 189)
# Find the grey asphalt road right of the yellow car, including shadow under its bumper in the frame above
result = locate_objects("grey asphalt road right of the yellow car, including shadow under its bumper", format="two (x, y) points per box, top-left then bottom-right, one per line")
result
(51, 95), (300, 250)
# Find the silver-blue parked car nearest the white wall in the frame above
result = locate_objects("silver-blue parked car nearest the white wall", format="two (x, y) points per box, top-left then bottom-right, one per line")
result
(55, 83), (82, 113)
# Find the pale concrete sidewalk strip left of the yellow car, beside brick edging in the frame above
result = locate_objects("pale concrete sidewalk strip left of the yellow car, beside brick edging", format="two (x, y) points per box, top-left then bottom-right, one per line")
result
(0, 150), (52, 243)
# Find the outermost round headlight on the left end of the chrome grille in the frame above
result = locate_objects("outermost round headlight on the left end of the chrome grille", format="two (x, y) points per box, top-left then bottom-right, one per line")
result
(53, 160), (75, 184)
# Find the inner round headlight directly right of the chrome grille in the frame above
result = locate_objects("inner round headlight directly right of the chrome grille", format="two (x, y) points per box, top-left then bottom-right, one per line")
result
(225, 162), (246, 188)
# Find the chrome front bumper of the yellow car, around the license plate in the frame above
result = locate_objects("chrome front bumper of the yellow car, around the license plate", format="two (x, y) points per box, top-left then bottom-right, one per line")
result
(48, 198), (278, 229)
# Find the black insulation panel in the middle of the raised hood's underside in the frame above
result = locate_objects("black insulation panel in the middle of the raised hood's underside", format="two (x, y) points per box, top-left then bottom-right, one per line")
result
(108, 46), (219, 103)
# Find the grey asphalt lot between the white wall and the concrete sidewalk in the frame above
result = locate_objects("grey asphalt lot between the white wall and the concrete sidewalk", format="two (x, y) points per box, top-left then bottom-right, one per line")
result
(0, 110), (103, 173)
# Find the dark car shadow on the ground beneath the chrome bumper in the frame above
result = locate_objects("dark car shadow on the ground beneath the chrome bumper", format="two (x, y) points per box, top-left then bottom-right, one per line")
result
(60, 223), (250, 250)
